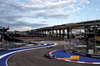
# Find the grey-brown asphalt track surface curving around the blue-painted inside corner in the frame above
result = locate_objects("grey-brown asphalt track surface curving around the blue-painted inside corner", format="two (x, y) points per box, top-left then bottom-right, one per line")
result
(7, 45), (100, 66)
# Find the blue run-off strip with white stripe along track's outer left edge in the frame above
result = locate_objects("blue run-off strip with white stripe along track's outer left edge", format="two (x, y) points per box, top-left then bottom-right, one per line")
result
(0, 43), (57, 66)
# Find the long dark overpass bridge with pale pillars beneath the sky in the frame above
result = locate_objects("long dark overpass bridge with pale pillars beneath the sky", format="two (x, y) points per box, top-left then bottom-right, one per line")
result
(26, 20), (100, 37)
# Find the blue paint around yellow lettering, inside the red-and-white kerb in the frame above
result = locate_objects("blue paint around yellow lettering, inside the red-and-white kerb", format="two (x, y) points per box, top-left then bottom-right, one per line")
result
(52, 49), (100, 63)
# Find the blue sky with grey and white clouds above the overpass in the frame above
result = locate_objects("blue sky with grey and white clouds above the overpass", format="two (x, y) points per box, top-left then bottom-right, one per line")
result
(0, 0), (100, 31)
